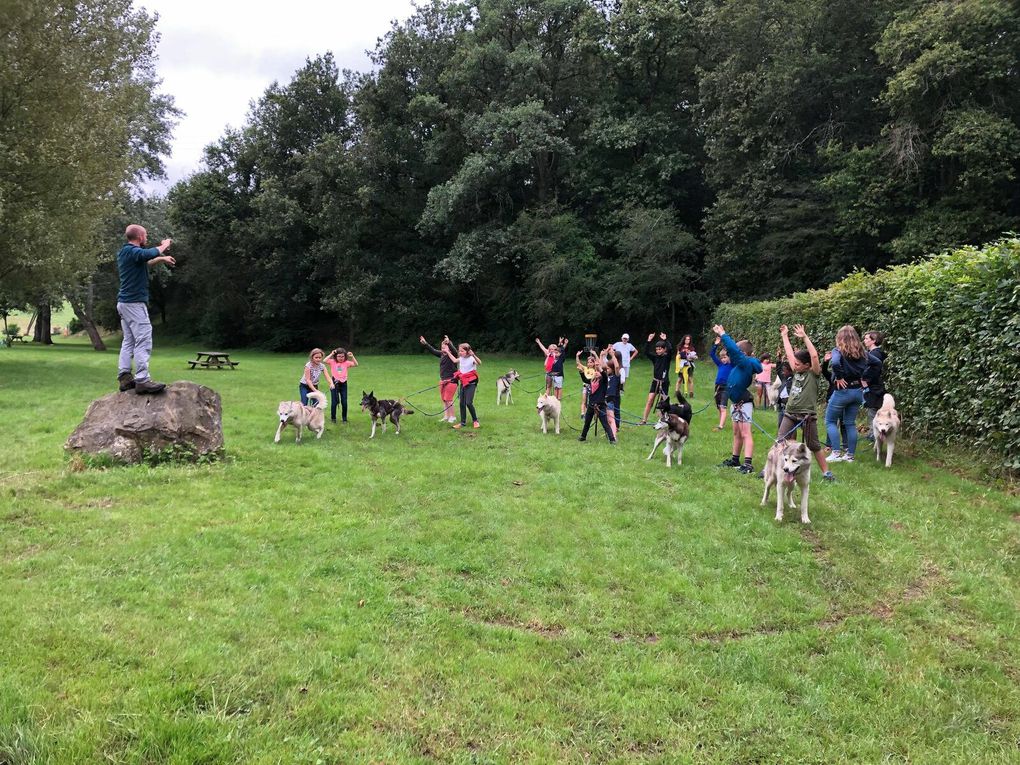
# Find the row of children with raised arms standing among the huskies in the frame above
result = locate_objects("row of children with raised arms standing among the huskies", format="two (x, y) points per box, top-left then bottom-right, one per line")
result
(299, 324), (885, 471)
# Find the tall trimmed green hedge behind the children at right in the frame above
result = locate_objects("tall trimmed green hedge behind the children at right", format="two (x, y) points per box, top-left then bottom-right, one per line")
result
(715, 238), (1020, 470)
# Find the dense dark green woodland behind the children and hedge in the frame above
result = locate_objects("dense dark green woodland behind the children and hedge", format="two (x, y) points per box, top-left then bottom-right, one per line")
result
(165, 0), (1020, 348)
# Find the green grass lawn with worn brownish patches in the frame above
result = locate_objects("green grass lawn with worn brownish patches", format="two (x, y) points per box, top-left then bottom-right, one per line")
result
(0, 342), (1020, 765)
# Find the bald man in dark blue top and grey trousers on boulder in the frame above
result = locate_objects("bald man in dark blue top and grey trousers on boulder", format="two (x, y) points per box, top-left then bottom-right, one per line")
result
(117, 223), (176, 394)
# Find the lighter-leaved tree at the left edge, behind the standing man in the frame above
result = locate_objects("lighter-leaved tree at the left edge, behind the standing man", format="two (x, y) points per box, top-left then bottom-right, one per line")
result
(0, 0), (177, 345)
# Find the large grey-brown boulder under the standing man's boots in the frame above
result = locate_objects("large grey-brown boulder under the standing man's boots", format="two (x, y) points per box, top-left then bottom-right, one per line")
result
(64, 381), (223, 462)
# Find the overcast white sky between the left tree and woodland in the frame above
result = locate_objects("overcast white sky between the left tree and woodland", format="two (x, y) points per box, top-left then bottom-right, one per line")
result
(136, 0), (414, 190)
